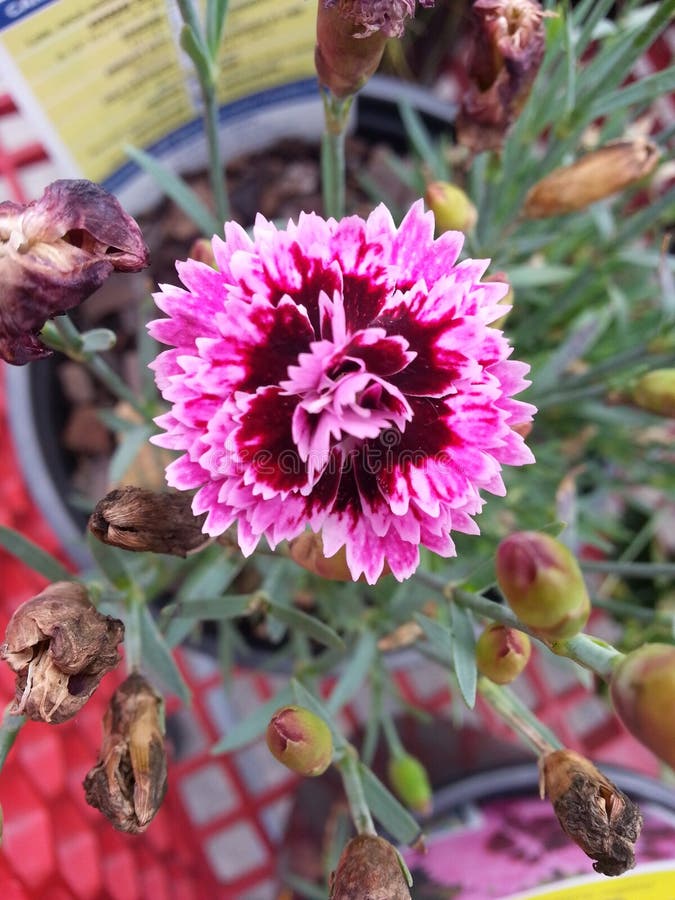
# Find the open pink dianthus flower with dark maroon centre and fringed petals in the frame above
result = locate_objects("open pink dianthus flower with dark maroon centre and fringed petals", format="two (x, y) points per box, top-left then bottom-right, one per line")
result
(150, 201), (534, 583)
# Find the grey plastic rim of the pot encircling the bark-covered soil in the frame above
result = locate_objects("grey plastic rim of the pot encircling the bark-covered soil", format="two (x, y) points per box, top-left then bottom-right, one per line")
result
(6, 77), (454, 568)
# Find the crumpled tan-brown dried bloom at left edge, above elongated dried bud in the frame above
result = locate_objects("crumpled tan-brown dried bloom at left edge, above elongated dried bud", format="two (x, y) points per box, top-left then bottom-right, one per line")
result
(0, 581), (124, 723)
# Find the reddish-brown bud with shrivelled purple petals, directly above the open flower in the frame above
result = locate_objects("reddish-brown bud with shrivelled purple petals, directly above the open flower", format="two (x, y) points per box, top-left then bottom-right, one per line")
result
(314, 0), (434, 97)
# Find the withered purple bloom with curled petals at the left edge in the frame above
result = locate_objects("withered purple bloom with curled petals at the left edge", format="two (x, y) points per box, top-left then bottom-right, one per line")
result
(0, 180), (148, 365)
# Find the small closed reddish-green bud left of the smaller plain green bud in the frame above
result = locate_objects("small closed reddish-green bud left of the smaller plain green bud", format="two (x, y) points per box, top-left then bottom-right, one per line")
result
(266, 706), (333, 776)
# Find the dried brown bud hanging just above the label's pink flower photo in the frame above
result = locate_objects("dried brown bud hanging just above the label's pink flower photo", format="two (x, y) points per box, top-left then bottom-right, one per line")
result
(540, 750), (642, 875)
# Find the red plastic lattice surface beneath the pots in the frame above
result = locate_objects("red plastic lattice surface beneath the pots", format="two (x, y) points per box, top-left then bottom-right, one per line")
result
(0, 61), (657, 900)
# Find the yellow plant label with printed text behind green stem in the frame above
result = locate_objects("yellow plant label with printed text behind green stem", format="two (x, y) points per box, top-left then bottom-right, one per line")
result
(0, 0), (318, 204)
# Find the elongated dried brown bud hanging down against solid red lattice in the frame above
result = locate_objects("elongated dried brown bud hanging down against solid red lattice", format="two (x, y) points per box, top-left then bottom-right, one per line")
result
(84, 673), (167, 834)
